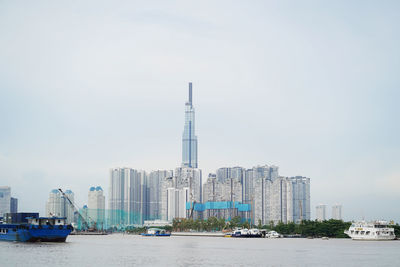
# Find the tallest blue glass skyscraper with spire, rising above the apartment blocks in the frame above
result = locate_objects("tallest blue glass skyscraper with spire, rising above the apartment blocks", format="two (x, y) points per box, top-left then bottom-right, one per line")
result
(182, 82), (198, 168)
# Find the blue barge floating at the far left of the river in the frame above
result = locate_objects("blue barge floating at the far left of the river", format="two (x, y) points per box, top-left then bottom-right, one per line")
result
(0, 213), (73, 242)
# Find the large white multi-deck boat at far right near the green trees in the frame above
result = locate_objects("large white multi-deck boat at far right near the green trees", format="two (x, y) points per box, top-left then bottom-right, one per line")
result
(344, 221), (396, 240)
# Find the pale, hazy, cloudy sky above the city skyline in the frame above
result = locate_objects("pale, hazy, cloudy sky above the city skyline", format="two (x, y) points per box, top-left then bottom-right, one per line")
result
(0, 0), (400, 222)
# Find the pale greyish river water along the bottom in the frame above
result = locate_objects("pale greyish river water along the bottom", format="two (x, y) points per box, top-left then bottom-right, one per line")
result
(0, 234), (400, 266)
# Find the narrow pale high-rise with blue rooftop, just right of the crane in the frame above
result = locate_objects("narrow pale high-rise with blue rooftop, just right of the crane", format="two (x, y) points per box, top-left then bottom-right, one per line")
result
(87, 186), (106, 229)
